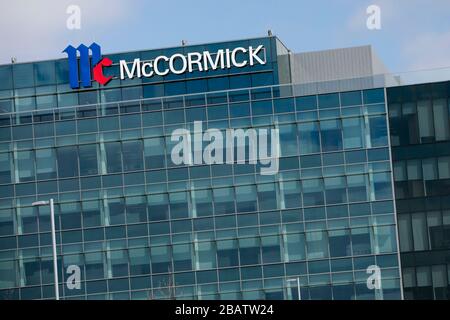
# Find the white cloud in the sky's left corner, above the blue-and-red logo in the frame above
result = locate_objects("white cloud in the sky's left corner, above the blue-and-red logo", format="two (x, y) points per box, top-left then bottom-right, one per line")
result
(0, 0), (132, 63)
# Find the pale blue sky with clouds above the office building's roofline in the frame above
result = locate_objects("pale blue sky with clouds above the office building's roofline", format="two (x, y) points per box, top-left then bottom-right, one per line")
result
(0, 0), (450, 72)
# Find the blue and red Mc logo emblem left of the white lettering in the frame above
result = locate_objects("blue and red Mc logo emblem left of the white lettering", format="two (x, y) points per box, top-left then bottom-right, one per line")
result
(63, 42), (112, 89)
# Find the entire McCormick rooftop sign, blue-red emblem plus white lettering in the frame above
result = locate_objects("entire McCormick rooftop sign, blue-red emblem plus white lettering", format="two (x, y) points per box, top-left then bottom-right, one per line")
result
(63, 42), (266, 89)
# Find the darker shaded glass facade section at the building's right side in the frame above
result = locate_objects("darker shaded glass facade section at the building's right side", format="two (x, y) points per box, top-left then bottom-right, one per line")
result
(387, 82), (450, 300)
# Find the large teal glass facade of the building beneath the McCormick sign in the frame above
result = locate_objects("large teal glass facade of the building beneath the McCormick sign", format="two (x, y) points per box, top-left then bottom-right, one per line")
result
(0, 37), (404, 300)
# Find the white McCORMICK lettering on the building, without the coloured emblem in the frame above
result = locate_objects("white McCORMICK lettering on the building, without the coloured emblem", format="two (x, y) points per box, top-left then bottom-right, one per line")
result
(119, 45), (266, 80)
